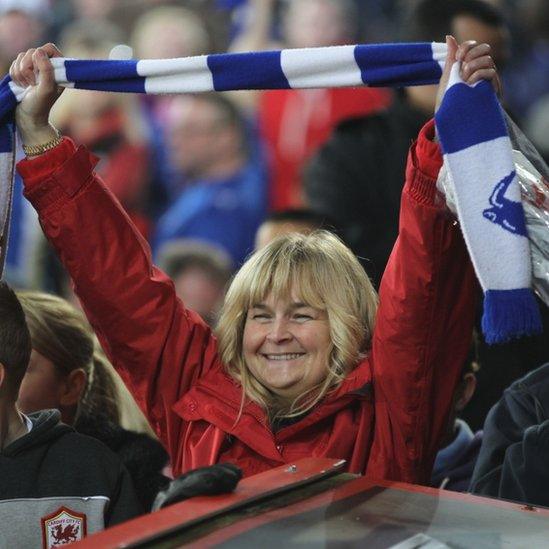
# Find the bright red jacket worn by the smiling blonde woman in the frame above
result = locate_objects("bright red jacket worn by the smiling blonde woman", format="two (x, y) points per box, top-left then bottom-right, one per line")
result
(18, 119), (474, 483)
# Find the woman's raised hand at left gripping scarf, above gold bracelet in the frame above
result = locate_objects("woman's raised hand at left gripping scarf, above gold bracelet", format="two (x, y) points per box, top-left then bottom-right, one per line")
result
(10, 43), (63, 145)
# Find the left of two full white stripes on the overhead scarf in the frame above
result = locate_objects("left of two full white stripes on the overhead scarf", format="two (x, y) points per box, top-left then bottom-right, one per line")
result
(136, 55), (213, 93)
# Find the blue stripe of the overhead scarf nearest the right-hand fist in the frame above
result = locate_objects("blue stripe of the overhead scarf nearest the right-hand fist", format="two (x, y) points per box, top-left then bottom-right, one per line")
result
(354, 43), (442, 86)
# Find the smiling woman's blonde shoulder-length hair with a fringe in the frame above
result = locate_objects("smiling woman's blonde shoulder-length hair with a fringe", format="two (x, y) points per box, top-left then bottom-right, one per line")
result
(217, 231), (377, 421)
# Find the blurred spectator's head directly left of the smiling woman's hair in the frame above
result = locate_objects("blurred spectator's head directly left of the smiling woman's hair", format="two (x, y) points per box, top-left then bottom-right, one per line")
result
(157, 240), (232, 327)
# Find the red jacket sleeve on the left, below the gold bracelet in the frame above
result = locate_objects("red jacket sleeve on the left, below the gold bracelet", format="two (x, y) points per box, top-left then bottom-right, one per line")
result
(18, 138), (222, 459)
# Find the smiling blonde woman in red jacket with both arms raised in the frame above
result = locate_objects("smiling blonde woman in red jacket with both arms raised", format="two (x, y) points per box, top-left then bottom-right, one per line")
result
(10, 40), (495, 482)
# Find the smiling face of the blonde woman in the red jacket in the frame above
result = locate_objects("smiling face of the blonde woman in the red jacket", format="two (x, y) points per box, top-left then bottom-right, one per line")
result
(243, 295), (332, 400)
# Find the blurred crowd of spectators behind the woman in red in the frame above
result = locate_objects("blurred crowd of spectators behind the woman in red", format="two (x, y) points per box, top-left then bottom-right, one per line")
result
(0, 0), (549, 540)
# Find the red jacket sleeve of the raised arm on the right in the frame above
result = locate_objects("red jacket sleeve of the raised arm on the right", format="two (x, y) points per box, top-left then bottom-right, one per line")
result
(366, 121), (476, 484)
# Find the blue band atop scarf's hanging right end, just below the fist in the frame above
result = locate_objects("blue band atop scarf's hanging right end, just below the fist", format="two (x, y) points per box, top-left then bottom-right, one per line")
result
(435, 81), (507, 154)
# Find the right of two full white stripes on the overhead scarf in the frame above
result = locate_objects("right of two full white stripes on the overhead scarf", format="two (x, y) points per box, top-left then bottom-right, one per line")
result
(280, 46), (364, 88)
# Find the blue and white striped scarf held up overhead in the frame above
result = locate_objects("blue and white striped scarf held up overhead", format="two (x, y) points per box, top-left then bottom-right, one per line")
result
(0, 43), (541, 343)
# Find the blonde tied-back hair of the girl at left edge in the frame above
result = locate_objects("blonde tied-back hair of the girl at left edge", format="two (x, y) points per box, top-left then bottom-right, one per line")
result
(17, 291), (152, 434)
